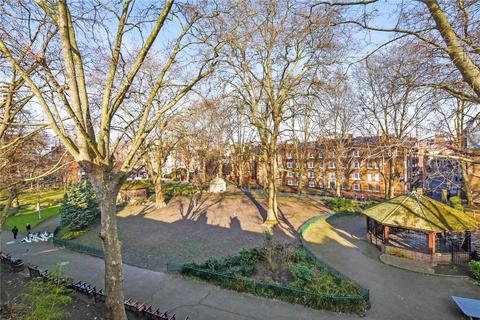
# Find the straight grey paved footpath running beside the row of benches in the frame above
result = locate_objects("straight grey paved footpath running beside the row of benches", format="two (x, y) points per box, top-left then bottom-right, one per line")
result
(0, 220), (359, 320)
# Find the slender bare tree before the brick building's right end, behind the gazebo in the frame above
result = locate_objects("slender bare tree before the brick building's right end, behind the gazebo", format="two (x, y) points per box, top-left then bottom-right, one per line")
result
(357, 43), (432, 198)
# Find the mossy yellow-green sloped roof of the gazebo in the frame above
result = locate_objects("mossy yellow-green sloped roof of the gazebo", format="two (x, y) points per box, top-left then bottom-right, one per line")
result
(363, 192), (477, 232)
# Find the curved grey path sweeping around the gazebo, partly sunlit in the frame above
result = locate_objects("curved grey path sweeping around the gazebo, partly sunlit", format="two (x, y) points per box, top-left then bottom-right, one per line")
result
(304, 216), (480, 320)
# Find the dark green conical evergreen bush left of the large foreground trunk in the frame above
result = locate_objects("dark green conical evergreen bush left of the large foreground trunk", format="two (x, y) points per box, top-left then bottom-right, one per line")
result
(60, 181), (100, 231)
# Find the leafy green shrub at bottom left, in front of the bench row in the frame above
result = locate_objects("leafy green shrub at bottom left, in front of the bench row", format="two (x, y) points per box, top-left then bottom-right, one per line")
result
(22, 268), (72, 320)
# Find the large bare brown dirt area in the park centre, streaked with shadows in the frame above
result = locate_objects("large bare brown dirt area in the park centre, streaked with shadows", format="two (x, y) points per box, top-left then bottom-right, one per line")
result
(74, 191), (328, 271)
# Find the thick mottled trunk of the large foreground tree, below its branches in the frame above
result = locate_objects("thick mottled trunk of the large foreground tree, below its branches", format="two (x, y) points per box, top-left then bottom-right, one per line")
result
(89, 171), (127, 320)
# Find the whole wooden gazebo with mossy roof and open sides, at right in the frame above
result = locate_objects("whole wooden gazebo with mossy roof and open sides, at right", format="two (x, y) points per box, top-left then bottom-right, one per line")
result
(363, 192), (477, 262)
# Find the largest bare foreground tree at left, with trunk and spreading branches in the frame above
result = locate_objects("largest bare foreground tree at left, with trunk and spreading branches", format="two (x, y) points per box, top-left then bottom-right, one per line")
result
(0, 0), (217, 320)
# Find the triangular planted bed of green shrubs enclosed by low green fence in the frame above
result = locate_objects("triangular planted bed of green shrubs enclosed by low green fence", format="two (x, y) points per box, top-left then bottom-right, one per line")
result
(169, 238), (368, 313)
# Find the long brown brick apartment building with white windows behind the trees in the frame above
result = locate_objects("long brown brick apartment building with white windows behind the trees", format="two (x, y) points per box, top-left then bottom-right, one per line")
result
(234, 137), (422, 197)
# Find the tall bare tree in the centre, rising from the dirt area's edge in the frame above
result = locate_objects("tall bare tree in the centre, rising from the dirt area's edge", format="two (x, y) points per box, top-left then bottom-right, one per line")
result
(221, 0), (338, 225)
